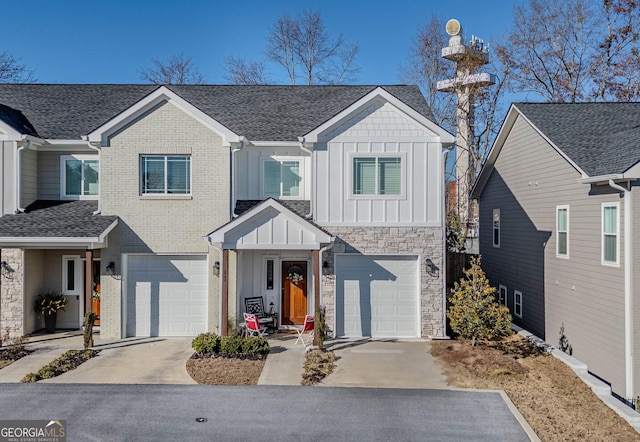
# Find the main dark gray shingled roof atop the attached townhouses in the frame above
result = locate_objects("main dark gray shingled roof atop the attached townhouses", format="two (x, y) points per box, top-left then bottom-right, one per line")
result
(0, 84), (434, 141)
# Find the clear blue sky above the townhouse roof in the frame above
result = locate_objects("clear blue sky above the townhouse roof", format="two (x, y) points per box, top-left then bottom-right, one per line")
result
(0, 0), (522, 84)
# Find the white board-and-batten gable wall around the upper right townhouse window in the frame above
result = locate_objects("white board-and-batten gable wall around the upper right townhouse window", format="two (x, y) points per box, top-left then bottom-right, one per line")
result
(314, 102), (442, 226)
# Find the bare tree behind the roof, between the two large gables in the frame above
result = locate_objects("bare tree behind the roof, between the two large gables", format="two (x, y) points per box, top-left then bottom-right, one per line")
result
(266, 10), (359, 85)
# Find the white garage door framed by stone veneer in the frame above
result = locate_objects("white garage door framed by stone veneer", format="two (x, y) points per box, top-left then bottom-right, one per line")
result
(336, 255), (420, 338)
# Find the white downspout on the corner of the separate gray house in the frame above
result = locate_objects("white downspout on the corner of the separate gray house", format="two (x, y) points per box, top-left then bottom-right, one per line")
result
(609, 180), (633, 400)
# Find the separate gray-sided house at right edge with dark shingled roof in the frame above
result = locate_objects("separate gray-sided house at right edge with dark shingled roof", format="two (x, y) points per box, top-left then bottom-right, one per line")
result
(472, 103), (640, 399)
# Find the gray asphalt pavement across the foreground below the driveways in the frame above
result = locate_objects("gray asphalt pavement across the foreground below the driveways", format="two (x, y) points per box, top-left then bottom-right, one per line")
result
(0, 384), (535, 442)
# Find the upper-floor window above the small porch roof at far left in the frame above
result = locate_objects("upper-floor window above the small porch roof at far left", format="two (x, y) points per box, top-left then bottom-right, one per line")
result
(60, 155), (99, 199)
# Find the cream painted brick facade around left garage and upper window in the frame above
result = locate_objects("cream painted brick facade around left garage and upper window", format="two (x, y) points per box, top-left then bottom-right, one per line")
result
(100, 103), (231, 338)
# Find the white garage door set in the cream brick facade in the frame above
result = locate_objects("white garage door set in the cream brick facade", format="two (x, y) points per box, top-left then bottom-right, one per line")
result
(127, 255), (208, 336)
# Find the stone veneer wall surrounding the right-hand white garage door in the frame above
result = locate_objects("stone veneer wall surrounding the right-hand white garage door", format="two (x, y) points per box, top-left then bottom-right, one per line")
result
(321, 227), (445, 337)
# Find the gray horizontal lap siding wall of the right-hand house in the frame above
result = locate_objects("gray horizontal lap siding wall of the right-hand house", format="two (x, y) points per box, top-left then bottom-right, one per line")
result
(480, 117), (625, 394)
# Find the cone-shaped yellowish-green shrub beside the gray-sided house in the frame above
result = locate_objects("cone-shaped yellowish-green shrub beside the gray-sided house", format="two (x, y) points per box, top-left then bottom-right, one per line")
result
(447, 258), (511, 345)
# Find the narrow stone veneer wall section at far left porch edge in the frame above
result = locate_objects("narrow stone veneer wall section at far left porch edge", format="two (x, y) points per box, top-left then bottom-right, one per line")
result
(0, 249), (24, 338)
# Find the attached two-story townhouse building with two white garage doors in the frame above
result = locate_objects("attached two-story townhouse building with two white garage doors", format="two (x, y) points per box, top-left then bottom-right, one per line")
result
(0, 85), (454, 344)
